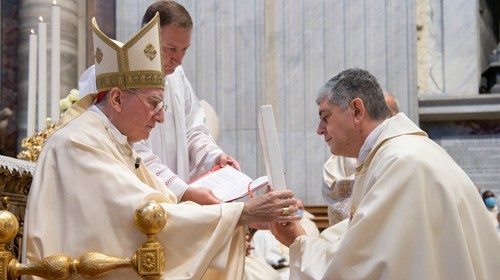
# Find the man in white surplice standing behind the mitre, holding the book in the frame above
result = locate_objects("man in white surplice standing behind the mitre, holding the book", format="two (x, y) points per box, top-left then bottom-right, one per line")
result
(79, 0), (240, 204)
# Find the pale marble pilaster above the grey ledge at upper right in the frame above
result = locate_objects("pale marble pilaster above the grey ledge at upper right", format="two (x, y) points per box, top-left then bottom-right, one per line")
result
(417, 0), (484, 97)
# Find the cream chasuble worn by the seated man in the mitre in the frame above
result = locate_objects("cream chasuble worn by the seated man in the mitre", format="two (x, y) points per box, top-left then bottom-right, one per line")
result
(24, 107), (244, 279)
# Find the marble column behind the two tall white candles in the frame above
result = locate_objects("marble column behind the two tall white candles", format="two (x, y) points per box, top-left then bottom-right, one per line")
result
(17, 0), (78, 140)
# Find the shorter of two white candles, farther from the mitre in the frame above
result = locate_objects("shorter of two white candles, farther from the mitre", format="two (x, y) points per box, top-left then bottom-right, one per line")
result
(38, 17), (47, 131)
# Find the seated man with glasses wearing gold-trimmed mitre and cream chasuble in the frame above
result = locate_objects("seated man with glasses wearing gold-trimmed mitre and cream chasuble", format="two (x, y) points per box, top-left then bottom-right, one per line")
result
(23, 15), (298, 280)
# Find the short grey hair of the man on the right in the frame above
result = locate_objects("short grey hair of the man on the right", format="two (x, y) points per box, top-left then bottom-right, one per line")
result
(316, 68), (392, 120)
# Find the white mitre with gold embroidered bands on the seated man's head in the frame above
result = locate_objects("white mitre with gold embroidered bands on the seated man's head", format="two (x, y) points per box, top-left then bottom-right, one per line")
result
(92, 13), (165, 92)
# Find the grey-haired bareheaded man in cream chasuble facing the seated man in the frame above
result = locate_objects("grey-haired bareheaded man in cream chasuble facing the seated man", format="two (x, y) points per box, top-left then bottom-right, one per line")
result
(272, 69), (500, 280)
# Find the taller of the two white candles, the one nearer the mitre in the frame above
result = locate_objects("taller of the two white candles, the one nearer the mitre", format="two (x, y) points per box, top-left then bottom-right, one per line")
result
(50, 1), (61, 122)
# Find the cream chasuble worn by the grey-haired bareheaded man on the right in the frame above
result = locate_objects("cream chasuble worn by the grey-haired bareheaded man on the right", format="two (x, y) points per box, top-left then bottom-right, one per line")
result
(290, 113), (500, 280)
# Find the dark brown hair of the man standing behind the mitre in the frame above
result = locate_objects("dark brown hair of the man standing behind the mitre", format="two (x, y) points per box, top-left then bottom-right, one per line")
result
(142, 1), (193, 29)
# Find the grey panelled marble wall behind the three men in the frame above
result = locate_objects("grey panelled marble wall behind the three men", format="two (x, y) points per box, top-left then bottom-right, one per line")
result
(116, 0), (418, 204)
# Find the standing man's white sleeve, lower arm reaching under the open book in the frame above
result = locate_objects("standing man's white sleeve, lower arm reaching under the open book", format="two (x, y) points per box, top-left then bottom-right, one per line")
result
(133, 141), (189, 201)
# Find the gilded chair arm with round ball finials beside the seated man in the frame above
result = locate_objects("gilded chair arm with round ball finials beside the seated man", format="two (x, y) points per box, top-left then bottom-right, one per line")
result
(0, 202), (166, 280)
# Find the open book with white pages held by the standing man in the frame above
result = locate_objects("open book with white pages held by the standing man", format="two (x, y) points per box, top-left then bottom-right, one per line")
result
(189, 165), (268, 202)
